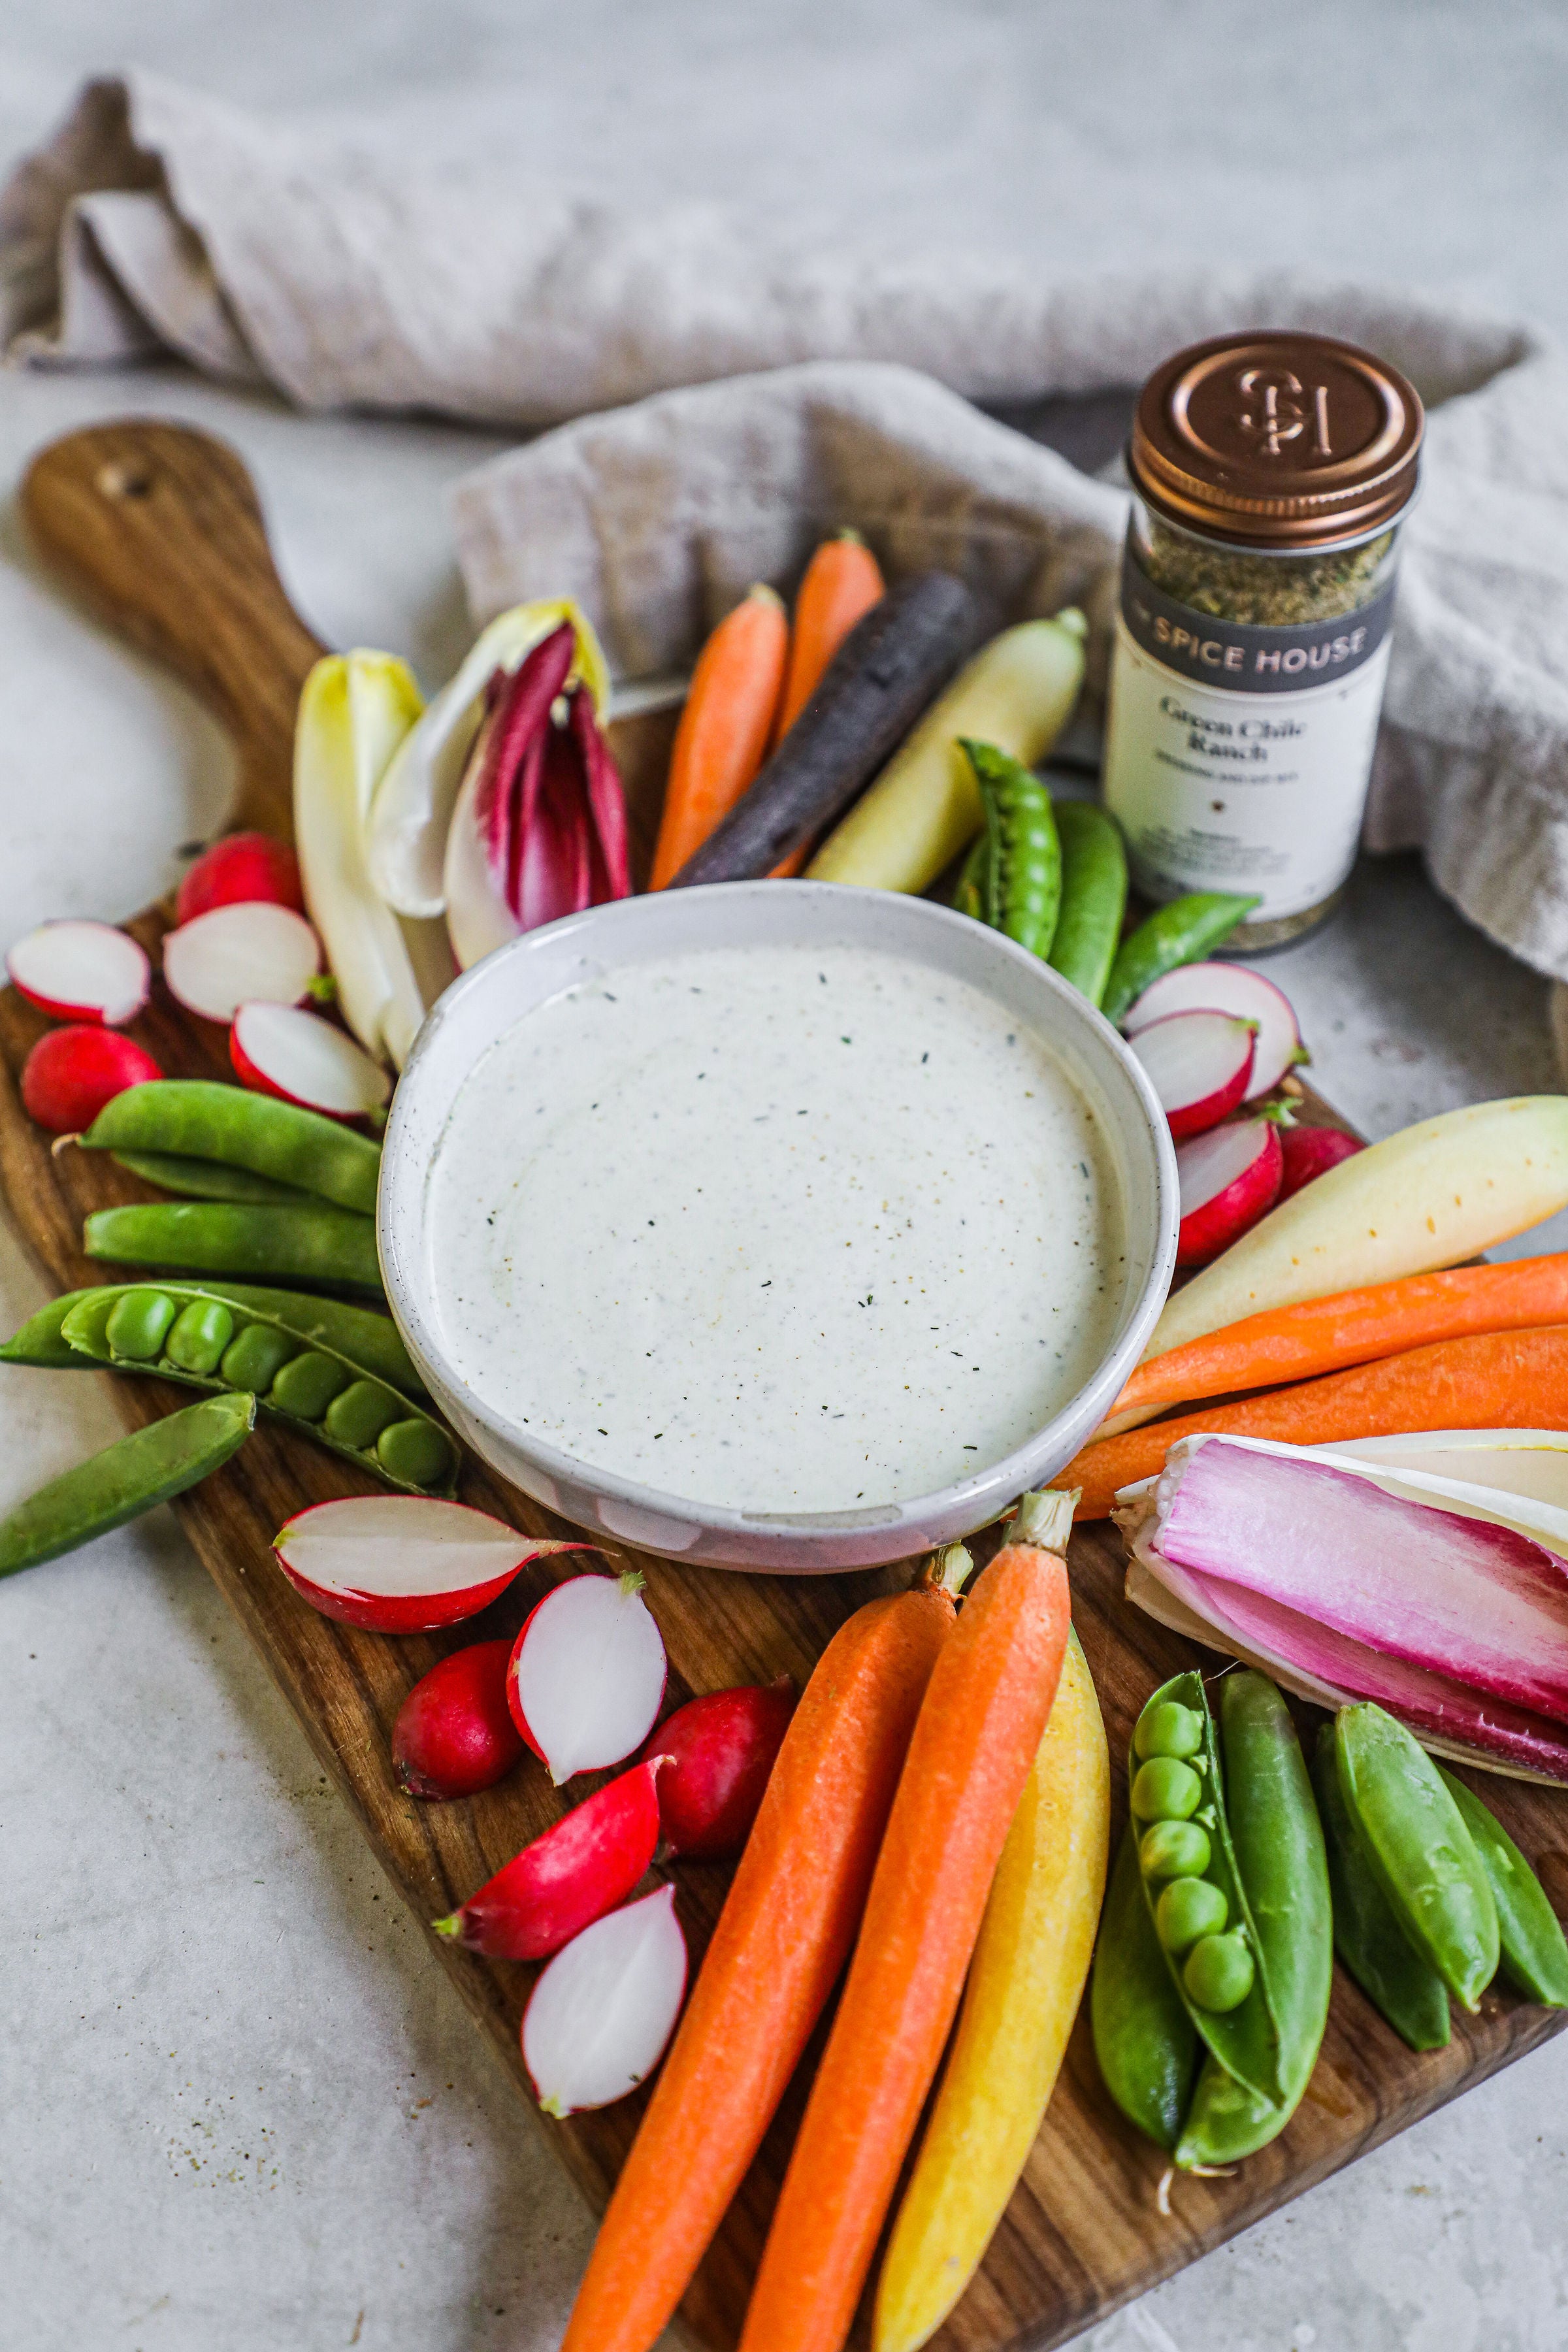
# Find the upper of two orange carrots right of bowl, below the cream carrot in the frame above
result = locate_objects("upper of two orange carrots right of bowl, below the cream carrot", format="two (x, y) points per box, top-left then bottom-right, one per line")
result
(1107, 1251), (1568, 1420)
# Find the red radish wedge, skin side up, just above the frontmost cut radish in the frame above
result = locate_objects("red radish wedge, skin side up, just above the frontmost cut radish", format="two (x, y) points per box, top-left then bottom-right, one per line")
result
(435, 1757), (665, 1959)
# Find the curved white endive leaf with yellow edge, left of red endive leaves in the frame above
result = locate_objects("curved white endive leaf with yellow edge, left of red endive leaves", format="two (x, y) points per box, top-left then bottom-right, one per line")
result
(369, 597), (609, 917)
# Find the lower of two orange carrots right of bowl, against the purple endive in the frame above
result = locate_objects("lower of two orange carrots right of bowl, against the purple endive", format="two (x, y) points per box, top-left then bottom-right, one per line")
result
(1056, 1324), (1568, 1520)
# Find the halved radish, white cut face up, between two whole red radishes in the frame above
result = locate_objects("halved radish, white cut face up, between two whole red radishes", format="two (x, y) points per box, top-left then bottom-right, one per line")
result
(506, 1569), (665, 1788)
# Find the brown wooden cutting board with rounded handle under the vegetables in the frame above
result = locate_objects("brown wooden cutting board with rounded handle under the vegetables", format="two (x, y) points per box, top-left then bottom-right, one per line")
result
(12, 419), (1568, 2352)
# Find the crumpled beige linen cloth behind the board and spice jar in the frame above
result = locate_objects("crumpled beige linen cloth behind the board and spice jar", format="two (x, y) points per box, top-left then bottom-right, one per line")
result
(0, 75), (1568, 979)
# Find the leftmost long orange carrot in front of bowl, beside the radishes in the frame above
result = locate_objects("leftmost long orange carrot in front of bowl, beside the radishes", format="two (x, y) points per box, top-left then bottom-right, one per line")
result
(562, 1545), (968, 2352)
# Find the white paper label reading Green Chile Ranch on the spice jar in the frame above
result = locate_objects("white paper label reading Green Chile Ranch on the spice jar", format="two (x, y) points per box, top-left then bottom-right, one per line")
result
(1105, 612), (1390, 924)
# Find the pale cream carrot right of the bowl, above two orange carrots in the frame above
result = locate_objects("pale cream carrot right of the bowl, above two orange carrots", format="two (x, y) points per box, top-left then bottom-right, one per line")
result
(1145, 1094), (1568, 1360)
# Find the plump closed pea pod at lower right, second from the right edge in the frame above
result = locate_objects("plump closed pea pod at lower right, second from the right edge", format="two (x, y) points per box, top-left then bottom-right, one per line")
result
(1333, 1698), (1500, 2011)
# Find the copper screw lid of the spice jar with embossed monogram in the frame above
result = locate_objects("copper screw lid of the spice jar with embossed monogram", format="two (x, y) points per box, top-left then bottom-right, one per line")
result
(1128, 334), (1422, 550)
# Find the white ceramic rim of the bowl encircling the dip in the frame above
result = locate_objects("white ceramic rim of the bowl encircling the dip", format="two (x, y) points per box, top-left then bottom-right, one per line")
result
(376, 879), (1180, 1560)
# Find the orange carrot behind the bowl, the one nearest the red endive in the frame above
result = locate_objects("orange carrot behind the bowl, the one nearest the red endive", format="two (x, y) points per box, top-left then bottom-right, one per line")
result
(649, 588), (790, 889)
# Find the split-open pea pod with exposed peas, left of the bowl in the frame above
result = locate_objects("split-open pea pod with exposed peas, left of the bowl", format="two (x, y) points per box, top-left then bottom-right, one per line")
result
(61, 1282), (459, 1494)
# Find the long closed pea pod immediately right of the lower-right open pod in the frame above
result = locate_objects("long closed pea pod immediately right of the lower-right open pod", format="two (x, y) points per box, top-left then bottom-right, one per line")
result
(1175, 1673), (1333, 2171)
